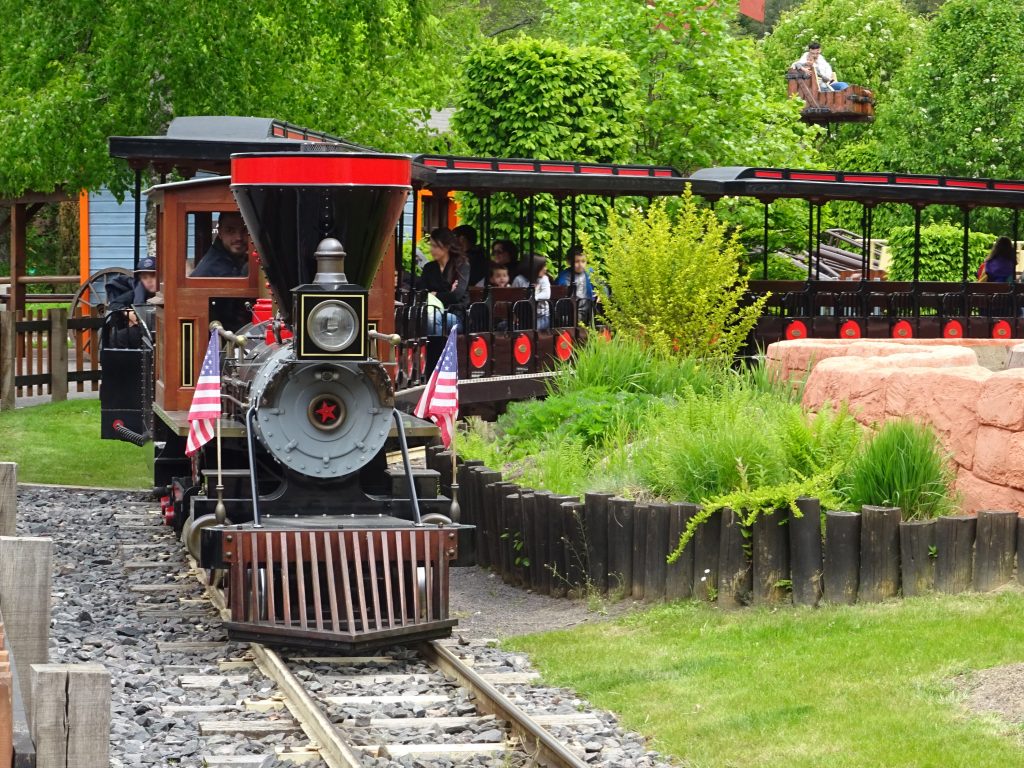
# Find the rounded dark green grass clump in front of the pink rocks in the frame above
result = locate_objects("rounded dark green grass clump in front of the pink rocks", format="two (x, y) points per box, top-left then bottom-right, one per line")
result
(840, 419), (958, 520)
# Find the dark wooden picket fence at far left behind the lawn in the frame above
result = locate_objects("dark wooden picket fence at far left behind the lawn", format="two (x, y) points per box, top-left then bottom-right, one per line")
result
(0, 309), (103, 411)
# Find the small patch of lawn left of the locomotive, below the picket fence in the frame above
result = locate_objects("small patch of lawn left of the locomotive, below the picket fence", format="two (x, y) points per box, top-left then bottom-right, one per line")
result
(0, 399), (153, 488)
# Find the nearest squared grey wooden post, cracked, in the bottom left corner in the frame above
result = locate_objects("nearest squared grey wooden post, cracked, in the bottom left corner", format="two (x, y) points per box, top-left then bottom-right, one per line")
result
(31, 664), (111, 768)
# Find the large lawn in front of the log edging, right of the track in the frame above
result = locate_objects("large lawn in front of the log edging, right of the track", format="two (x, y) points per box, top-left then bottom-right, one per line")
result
(507, 591), (1024, 768)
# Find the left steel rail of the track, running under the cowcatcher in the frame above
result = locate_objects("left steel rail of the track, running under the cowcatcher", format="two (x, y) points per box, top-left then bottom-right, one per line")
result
(200, 571), (362, 768)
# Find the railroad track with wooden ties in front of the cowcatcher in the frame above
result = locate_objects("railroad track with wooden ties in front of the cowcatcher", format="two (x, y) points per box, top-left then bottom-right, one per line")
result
(121, 505), (615, 768)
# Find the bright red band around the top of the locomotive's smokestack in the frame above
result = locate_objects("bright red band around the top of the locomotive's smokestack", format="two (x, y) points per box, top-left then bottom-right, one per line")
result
(231, 153), (413, 186)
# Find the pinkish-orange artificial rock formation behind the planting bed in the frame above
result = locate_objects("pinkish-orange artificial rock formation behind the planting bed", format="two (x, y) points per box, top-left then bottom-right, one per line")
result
(767, 339), (1024, 514)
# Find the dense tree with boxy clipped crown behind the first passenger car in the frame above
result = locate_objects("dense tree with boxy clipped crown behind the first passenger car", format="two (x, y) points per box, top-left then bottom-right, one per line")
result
(452, 38), (636, 254)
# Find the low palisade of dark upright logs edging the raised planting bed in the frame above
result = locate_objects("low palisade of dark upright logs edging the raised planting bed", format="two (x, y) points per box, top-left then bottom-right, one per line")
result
(427, 449), (1024, 607)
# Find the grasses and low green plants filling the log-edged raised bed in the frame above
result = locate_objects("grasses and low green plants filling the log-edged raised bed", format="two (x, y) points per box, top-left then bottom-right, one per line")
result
(460, 335), (953, 528)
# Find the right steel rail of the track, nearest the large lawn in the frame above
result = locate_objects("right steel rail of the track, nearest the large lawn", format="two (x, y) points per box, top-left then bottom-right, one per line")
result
(418, 640), (590, 768)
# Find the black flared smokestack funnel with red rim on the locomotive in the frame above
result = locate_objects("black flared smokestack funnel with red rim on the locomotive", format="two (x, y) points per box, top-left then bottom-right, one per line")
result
(231, 153), (412, 323)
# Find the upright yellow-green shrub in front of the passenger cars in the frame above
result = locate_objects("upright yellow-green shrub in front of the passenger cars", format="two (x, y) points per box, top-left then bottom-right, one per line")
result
(597, 191), (767, 360)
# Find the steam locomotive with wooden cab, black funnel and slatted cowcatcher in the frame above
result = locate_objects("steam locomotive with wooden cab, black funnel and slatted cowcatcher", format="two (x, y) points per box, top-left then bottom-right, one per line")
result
(100, 143), (461, 652)
